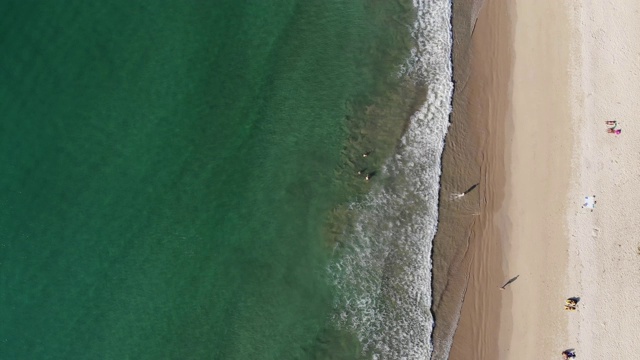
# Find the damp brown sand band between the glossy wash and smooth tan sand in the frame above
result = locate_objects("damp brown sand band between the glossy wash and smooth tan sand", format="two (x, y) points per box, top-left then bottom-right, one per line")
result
(450, 0), (515, 360)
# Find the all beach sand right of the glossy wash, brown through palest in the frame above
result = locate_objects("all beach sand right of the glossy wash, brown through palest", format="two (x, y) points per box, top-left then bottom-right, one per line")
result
(450, 0), (640, 360)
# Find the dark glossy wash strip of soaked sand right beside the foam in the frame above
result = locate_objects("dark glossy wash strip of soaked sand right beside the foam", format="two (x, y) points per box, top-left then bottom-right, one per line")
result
(431, 0), (483, 360)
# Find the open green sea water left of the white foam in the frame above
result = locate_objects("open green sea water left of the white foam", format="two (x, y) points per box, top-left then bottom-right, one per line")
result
(0, 0), (411, 359)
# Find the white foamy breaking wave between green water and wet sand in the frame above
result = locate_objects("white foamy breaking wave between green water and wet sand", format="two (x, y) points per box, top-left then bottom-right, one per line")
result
(330, 0), (453, 359)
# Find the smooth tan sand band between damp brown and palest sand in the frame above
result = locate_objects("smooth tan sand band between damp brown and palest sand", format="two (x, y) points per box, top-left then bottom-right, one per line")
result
(499, 0), (572, 359)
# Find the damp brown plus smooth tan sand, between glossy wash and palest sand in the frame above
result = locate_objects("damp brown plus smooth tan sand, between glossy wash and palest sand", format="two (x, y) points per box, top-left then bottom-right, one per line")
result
(434, 0), (576, 360)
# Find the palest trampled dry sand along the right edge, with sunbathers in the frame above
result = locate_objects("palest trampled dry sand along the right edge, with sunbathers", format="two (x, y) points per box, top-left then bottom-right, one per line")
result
(567, 0), (640, 359)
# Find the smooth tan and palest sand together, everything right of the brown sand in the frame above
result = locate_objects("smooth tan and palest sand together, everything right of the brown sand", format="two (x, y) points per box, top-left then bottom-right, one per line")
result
(500, 0), (640, 359)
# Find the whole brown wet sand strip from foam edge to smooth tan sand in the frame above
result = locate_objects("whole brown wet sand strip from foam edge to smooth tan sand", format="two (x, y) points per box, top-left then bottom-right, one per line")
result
(433, 0), (513, 360)
